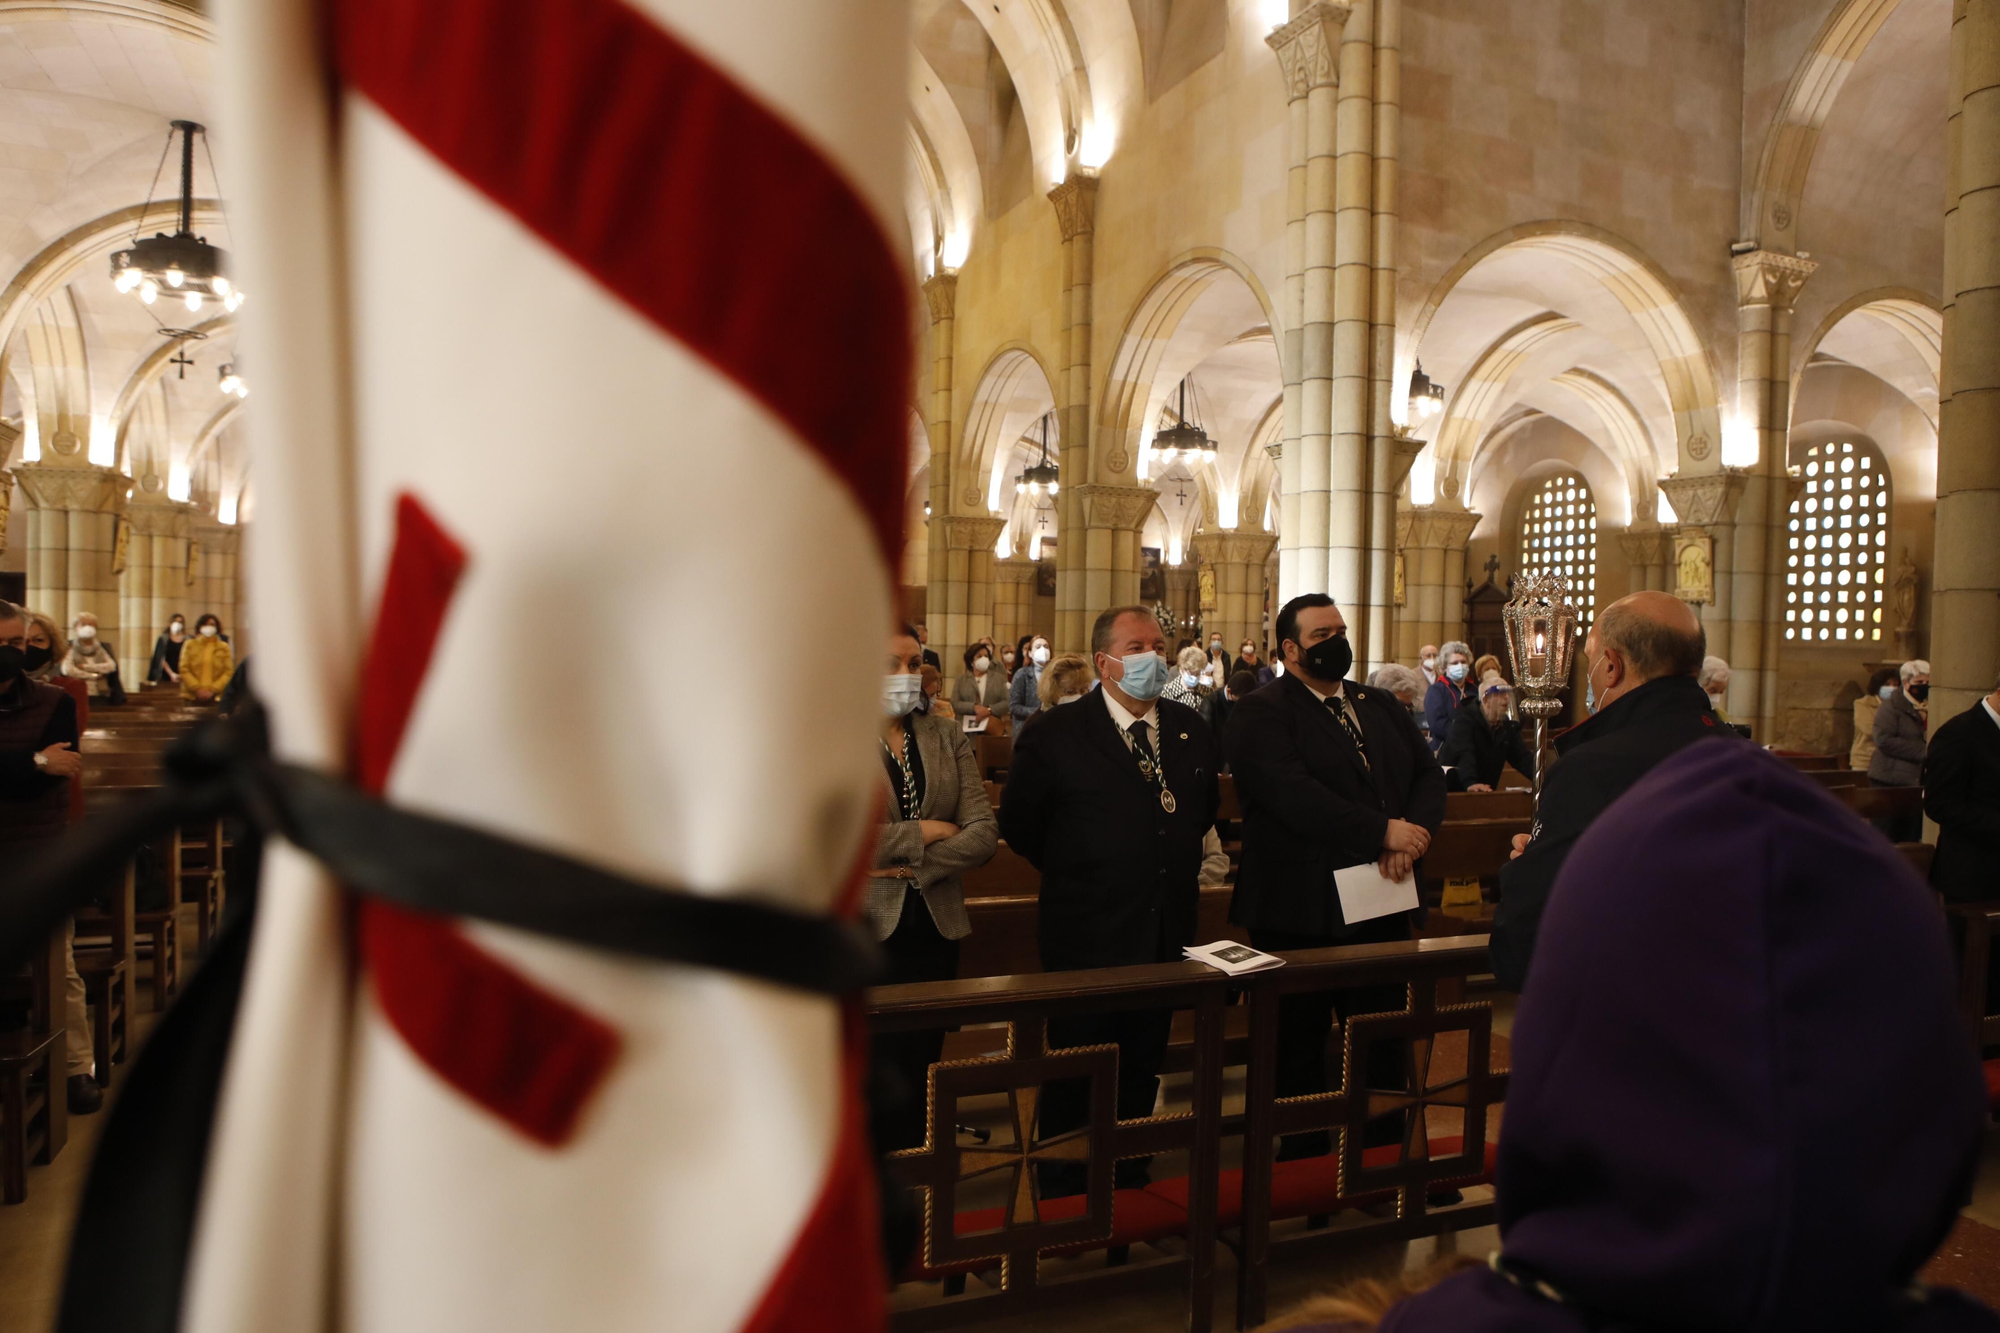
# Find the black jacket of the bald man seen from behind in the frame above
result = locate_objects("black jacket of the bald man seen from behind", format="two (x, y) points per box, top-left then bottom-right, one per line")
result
(1490, 677), (1740, 991)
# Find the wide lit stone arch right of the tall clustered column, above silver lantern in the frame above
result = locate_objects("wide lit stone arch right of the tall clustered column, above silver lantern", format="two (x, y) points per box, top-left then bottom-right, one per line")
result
(1396, 220), (1722, 470)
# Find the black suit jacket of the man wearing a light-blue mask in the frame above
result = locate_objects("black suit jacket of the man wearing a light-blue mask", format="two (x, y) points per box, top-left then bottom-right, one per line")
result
(1000, 689), (1222, 971)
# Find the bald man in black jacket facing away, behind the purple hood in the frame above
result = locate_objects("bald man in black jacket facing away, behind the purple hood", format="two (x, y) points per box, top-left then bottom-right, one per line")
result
(1492, 592), (1738, 991)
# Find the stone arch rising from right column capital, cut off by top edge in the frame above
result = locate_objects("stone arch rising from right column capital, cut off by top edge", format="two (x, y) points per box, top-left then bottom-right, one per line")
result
(1742, 0), (1902, 254)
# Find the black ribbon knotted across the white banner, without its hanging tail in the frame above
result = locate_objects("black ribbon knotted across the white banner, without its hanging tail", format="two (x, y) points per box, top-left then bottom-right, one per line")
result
(0, 701), (882, 995)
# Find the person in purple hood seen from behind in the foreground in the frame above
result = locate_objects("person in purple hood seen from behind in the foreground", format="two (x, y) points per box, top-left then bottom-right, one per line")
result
(1296, 745), (2000, 1333)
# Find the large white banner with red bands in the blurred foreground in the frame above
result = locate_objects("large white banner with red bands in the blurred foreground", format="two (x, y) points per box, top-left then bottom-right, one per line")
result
(182, 0), (910, 1333)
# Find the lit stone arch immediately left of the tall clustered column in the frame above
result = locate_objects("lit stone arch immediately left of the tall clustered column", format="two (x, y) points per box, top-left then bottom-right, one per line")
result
(1090, 248), (1284, 484)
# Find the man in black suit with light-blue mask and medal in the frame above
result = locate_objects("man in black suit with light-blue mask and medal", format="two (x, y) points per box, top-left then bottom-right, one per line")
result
(1000, 606), (1222, 1195)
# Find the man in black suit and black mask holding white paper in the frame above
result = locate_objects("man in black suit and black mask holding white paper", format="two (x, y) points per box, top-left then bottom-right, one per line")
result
(1226, 592), (1444, 1159)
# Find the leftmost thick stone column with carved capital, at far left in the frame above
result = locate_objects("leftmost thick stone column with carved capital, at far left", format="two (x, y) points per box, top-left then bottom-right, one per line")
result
(14, 460), (132, 648)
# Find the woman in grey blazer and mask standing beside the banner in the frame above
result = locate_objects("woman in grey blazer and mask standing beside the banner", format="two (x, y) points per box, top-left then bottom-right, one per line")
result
(862, 628), (1000, 1153)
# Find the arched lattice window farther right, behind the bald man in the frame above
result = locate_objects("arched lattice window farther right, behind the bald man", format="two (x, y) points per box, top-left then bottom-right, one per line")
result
(1784, 440), (1888, 642)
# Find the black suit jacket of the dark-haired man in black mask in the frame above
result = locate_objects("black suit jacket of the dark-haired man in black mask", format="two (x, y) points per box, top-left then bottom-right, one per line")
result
(1224, 673), (1444, 939)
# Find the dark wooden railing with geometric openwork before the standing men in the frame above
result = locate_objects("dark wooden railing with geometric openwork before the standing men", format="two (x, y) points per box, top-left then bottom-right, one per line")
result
(868, 935), (1506, 1333)
